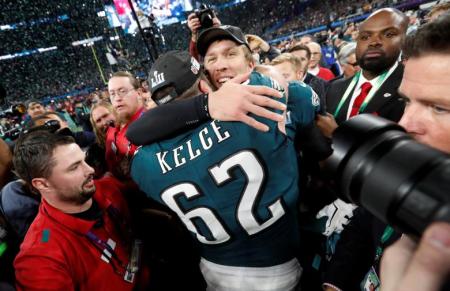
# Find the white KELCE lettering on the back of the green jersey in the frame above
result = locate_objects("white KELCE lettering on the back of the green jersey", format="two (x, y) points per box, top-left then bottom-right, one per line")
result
(156, 120), (231, 174)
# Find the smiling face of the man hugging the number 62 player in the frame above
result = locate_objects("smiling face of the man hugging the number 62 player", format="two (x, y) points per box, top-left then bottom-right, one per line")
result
(204, 40), (254, 89)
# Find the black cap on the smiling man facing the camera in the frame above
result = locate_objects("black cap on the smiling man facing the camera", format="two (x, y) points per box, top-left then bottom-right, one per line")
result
(197, 25), (251, 57)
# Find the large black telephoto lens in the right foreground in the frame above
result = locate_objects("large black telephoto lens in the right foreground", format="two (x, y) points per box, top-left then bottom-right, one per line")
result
(326, 114), (450, 237)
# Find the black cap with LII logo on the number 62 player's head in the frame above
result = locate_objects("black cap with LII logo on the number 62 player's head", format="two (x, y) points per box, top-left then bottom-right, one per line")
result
(148, 51), (201, 104)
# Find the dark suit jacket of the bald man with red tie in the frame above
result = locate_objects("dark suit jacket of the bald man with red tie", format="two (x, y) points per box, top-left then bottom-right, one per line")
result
(326, 64), (405, 124)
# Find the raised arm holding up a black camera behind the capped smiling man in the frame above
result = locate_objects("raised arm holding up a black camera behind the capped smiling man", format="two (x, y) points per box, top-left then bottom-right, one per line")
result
(188, 5), (222, 60)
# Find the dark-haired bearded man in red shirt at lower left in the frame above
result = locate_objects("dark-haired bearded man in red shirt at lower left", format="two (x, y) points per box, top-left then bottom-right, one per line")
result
(13, 131), (147, 290)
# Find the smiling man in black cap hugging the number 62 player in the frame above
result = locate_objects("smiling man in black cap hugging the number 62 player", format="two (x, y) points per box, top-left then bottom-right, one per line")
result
(123, 26), (286, 145)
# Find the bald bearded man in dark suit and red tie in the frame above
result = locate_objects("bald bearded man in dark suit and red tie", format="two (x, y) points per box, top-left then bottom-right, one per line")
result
(323, 8), (414, 291)
